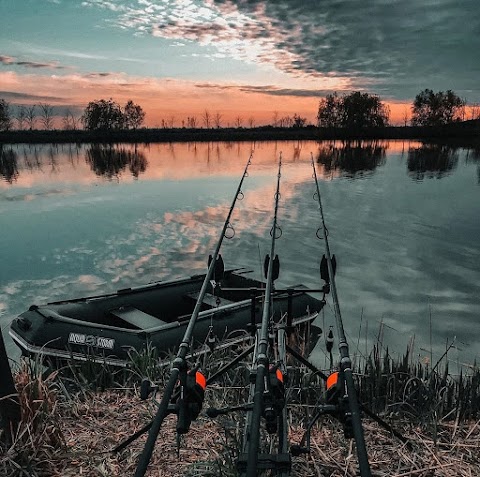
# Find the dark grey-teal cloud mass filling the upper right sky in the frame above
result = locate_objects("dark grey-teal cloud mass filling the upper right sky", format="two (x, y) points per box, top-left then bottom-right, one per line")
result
(213, 0), (480, 99)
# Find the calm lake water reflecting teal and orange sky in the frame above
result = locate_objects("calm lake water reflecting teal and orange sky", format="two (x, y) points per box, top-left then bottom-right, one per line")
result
(0, 142), (480, 365)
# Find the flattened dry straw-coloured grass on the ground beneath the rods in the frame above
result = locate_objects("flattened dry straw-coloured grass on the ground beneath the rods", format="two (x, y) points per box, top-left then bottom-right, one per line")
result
(0, 380), (480, 477)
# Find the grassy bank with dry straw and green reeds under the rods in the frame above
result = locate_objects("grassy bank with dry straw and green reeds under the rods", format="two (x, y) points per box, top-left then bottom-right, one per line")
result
(0, 336), (480, 477)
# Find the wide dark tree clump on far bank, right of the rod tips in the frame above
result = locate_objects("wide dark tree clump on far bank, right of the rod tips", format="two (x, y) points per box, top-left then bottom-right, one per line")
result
(317, 91), (390, 129)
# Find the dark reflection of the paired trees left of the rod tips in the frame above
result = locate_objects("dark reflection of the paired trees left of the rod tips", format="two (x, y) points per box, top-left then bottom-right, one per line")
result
(85, 144), (148, 180)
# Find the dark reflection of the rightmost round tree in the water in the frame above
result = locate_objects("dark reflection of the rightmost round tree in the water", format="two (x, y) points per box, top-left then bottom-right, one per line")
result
(407, 144), (458, 181)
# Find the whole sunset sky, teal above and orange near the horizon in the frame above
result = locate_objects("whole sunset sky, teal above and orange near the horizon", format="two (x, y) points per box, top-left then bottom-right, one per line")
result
(0, 0), (480, 127)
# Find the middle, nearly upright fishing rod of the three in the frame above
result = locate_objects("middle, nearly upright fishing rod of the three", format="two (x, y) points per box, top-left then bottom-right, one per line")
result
(243, 154), (282, 477)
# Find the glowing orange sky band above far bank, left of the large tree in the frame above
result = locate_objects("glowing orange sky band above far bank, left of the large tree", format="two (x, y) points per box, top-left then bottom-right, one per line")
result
(0, 72), (328, 127)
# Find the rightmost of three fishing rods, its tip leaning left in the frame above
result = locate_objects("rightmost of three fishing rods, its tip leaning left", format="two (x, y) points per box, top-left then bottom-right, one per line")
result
(311, 154), (371, 477)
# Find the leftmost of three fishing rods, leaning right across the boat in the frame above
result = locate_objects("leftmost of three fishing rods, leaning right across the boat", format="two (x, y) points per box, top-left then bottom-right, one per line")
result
(135, 151), (253, 477)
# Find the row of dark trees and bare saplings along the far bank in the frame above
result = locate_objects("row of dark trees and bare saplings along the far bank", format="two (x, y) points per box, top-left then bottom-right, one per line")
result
(0, 89), (480, 131)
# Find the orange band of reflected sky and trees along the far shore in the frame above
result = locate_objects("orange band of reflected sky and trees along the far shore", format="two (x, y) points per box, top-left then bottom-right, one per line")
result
(0, 141), (480, 187)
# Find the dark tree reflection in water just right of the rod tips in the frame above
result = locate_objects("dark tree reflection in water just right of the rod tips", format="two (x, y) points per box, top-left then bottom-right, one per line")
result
(317, 141), (388, 178)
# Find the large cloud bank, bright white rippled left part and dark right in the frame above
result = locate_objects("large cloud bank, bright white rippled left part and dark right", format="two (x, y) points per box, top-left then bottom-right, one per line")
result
(83, 0), (480, 101)
